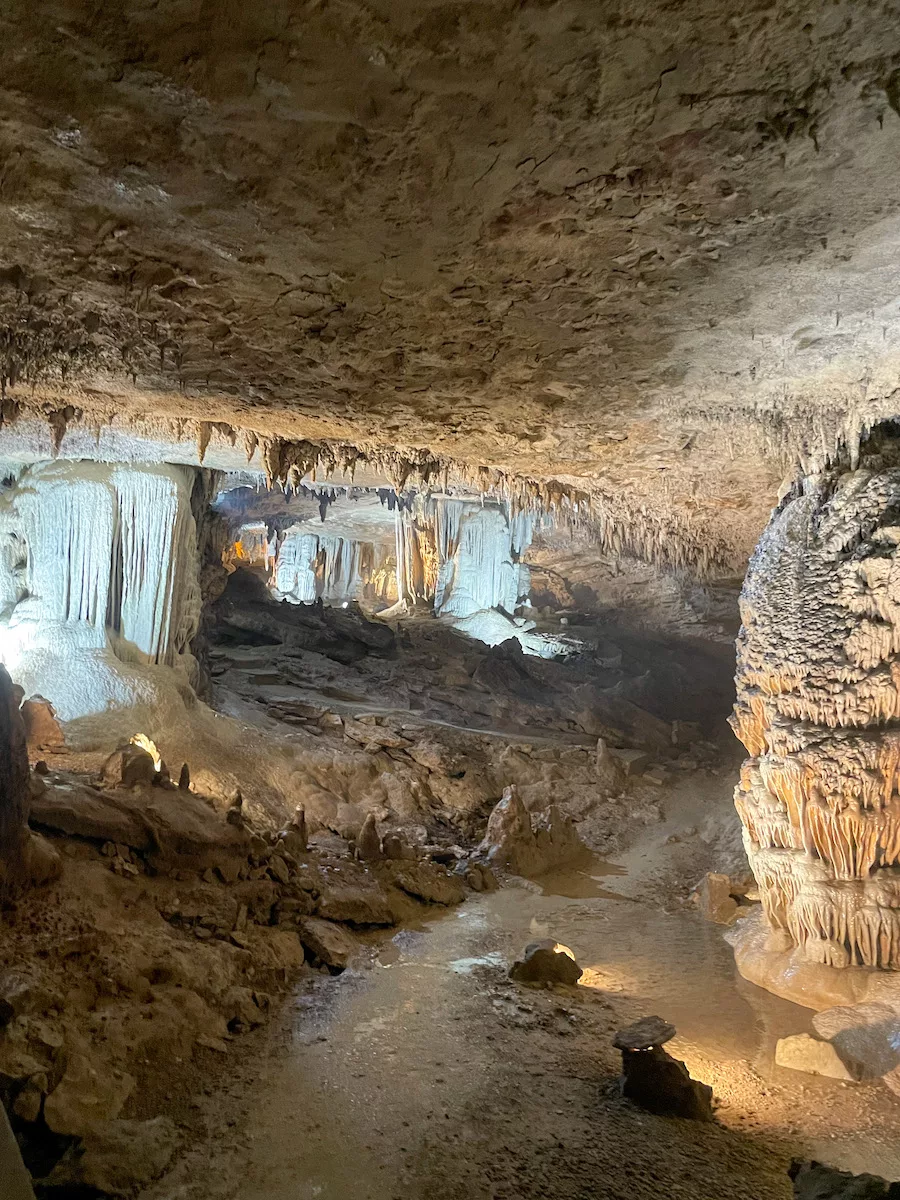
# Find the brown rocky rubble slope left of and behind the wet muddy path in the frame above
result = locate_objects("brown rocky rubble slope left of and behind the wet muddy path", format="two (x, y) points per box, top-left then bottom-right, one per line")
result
(0, 583), (763, 1196)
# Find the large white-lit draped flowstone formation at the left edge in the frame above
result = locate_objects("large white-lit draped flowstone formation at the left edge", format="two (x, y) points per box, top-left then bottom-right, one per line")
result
(0, 462), (200, 720)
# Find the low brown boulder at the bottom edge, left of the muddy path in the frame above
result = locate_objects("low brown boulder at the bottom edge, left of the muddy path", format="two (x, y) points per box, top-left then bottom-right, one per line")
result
(44, 1117), (179, 1196)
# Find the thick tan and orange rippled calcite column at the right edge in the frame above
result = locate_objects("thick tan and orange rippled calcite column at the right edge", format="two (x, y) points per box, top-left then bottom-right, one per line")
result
(732, 442), (900, 970)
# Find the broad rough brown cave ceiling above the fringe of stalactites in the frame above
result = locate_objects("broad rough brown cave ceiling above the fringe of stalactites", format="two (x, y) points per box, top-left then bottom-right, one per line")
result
(0, 0), (900, 563)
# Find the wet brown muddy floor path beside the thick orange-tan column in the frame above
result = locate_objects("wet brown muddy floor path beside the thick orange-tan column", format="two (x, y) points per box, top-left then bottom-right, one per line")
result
(135, 778), (900, 1200)
